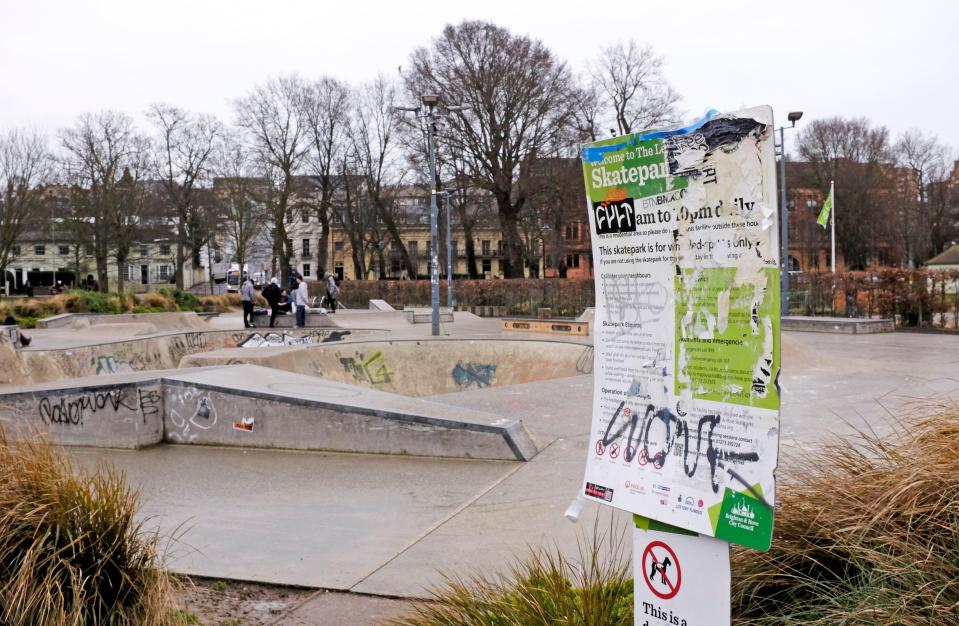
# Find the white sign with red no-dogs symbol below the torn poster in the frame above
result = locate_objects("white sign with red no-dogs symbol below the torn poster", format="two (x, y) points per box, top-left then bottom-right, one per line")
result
(633, 520), (730, 626)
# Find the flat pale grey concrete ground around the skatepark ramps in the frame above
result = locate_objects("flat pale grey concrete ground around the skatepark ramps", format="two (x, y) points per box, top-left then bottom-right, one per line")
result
(48, 312), (959, 624)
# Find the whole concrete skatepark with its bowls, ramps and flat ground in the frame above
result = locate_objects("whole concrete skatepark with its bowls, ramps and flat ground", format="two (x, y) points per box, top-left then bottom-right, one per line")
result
(0, 311), (959, 623)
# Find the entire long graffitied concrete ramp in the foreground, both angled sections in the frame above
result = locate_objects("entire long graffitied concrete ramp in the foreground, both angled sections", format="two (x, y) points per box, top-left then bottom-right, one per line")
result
(0, 365), (537, 460)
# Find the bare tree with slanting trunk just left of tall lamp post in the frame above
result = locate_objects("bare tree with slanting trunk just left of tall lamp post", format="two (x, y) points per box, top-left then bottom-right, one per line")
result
(344, 76), (416, 278)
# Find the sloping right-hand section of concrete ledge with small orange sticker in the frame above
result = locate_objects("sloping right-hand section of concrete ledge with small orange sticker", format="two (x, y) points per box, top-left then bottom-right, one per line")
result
(164, 365), (537, 461)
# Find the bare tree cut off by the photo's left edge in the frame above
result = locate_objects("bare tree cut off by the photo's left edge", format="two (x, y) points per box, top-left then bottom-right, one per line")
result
(0, 130), (53, 292)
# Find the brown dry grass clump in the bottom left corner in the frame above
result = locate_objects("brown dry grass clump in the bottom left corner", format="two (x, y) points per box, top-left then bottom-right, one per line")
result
(0, 431), (182, 626)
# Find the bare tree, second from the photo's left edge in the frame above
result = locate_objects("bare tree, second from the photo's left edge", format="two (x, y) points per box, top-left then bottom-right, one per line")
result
(60, 111), (146, 291)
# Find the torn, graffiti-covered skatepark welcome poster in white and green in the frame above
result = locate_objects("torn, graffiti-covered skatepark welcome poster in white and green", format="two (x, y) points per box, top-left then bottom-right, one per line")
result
(583, 107), (779, 550)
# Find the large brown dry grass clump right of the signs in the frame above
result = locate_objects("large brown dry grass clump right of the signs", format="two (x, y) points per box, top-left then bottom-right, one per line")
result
(732, 410), (959, 626)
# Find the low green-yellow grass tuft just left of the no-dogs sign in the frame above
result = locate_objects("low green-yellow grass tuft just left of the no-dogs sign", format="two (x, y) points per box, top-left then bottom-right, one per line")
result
(390, 527), (633, 626)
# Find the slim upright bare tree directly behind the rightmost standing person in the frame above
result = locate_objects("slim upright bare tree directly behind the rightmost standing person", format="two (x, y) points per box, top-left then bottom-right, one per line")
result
(304, 77), (352, 278)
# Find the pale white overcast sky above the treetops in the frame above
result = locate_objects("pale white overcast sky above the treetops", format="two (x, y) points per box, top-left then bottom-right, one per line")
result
(0, 0), (959, 154)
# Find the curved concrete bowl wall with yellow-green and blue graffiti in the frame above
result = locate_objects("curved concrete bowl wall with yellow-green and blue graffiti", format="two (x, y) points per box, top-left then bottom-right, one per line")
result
(181, 339), (593, 396)
